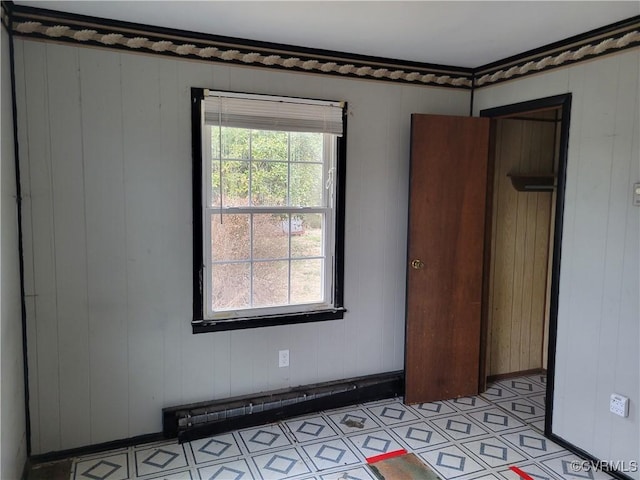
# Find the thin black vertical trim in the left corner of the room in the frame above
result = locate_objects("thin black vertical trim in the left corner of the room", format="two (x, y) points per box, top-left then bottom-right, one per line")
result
(2, 2), (31, 457)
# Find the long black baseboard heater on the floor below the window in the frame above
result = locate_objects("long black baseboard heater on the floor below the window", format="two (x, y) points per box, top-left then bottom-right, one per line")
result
(162, 371), (404, 443)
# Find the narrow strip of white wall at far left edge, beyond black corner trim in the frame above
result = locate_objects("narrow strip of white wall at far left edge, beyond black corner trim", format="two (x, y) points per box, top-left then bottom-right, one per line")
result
(0, 24), (27, 479)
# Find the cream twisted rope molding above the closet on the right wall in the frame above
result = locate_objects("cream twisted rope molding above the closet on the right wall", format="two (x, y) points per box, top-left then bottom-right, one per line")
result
(474, 30), (640, 87)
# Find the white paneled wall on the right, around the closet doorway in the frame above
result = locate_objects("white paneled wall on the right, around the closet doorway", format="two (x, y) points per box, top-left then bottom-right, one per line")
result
(475, 49), (640, 478)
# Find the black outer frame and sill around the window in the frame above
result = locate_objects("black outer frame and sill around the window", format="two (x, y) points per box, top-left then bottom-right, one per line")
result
(191, 87), (347, 333)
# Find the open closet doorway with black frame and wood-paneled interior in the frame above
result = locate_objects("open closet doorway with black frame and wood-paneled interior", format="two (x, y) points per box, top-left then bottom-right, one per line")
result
(479, 93), (571, 435)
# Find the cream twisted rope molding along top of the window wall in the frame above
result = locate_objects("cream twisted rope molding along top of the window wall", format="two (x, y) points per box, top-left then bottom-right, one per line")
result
(13, 22), (472, 88)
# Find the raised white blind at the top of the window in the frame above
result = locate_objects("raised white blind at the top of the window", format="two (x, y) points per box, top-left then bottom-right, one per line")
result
(204, 91), (343, 136)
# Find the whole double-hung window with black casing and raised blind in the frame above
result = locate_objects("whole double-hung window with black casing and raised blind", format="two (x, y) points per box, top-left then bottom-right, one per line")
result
(192, 88), (345, 333)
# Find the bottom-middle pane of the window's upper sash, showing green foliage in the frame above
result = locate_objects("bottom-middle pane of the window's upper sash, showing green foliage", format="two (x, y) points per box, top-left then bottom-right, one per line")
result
(251, 161), (289, 206)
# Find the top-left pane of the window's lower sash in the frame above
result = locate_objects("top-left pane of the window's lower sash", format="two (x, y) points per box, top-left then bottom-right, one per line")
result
(210, 213), (250, 261)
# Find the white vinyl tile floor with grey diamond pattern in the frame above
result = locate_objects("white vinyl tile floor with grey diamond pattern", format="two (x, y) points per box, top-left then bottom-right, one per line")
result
(70, 375), (611, 480)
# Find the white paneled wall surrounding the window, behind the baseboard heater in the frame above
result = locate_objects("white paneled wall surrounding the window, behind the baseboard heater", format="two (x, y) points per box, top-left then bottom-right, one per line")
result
(16, 40), (469, 454)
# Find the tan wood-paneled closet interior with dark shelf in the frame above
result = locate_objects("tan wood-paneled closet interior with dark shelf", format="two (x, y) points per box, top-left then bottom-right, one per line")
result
(485, 107), (562, 381)
